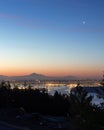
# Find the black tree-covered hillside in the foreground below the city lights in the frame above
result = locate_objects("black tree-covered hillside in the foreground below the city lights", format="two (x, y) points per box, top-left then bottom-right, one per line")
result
(0, 82), (104, 130)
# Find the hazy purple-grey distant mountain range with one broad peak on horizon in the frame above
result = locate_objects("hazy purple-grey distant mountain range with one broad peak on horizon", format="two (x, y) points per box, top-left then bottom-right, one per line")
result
(0, 73), (77, 81)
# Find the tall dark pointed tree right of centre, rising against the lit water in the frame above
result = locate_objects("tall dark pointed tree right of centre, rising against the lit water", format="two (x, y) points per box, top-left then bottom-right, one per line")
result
(70, 83), (93, 130)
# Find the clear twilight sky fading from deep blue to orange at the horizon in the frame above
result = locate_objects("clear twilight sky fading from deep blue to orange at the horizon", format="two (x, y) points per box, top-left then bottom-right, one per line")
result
(0, 0), (104, 77)
